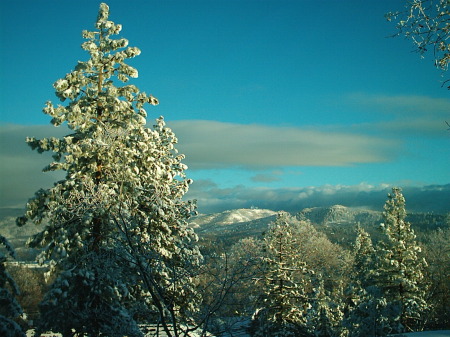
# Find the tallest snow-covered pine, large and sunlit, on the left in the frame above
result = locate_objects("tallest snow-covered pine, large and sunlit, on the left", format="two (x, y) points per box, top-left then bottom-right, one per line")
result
(17, 3), (201, 336)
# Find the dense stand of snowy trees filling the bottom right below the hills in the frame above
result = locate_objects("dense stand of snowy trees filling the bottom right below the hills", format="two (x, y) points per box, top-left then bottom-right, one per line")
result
(202, 188), (444, 336)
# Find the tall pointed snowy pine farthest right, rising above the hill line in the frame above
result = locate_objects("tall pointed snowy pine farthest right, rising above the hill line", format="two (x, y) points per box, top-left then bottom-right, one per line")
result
(375, 188), (428, 333)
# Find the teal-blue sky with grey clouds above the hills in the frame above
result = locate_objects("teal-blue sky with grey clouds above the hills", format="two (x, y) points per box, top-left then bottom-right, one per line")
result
(0, 0), (450, 212)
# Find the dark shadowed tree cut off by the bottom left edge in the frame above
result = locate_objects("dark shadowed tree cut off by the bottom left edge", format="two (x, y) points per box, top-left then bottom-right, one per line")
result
(0, 235), (25, 337)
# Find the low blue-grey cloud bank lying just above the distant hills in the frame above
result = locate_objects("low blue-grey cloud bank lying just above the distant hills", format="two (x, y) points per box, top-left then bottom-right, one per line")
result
(187, 181), (450, 213)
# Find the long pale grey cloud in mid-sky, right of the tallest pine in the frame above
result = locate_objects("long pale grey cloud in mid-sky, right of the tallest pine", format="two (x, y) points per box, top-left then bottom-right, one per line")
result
(169, 120), (399, 169)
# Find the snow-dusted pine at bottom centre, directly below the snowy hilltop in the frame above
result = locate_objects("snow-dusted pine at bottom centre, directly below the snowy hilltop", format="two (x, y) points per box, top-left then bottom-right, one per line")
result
(253, 212), (313, 337)
